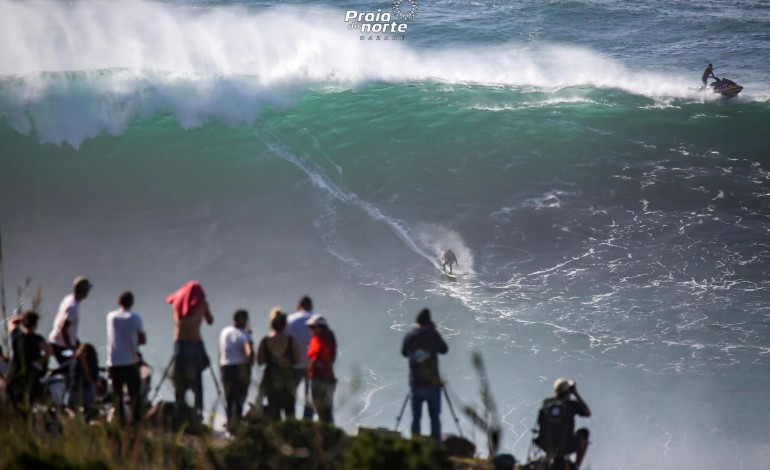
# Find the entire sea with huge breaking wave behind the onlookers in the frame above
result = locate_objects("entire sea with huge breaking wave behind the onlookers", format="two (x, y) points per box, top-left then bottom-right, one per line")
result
(0, 1), (770, 469)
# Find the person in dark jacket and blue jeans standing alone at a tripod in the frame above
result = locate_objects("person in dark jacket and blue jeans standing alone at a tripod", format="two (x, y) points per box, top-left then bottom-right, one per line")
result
(401, 308), (449, 442)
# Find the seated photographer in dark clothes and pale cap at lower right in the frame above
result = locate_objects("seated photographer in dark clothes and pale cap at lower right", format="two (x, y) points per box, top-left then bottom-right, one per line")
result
(535, 378), (591, 470)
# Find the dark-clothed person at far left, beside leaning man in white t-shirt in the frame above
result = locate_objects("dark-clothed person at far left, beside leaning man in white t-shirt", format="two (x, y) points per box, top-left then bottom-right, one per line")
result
(8, 310), (52, 410)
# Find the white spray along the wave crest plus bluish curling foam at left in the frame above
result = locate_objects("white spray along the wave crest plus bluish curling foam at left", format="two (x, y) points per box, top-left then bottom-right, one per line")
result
(0, 0), (760, 147)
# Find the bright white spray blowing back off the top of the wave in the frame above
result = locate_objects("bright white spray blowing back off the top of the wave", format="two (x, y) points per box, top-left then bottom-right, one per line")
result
(0, 0), (748, 98)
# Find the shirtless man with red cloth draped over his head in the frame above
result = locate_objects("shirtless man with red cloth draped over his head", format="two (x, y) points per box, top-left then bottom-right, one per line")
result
(166, 281), (214, 420)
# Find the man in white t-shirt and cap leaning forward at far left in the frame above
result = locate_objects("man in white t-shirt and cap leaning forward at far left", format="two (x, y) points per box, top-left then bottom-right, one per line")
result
(48, 276), (93, 364)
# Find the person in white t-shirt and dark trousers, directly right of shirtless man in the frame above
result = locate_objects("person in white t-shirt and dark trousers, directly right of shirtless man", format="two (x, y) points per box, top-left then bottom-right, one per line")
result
(219, 310), (254, 432)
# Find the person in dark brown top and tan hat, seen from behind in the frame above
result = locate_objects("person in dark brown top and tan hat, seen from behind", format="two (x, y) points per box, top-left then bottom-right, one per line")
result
(257, 307), (300, 421)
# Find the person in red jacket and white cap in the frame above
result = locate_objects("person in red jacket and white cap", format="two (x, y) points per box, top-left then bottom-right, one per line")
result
(307, 313), (337, 424)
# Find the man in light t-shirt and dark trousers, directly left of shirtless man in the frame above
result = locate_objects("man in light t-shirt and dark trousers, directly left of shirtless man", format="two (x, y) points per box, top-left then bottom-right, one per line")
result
(107, 291), (147, 425)
